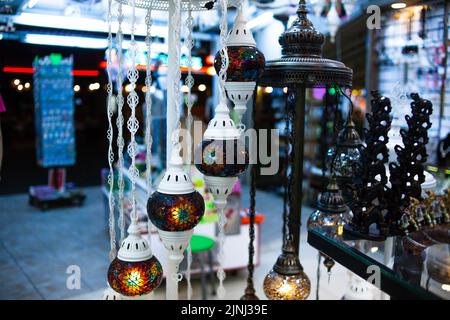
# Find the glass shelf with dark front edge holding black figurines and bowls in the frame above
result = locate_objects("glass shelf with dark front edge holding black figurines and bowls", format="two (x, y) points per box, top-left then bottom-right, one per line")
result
(308, 225), (450, 300)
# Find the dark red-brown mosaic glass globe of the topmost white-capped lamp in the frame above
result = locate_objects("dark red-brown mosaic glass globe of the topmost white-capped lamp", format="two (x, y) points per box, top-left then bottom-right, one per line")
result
(214, 46), (266, 82)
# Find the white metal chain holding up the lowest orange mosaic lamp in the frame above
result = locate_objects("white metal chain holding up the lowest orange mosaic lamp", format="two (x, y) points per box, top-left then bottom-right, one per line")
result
(127, 0), (139, 222)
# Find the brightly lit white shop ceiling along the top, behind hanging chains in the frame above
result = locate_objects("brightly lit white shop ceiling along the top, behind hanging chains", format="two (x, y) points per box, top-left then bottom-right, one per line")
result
(0, 0), (414, 48)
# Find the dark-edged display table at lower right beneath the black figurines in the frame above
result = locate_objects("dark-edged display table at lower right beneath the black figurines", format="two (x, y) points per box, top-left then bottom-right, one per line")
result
(308, 228), (450, 300)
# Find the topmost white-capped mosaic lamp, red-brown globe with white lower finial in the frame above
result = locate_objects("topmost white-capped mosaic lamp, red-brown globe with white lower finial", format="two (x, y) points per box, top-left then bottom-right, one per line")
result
(214, 6), (265, 130)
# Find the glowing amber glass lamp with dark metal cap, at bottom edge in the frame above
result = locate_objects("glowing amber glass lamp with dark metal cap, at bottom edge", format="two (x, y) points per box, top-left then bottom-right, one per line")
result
(263, 240), (311, 300)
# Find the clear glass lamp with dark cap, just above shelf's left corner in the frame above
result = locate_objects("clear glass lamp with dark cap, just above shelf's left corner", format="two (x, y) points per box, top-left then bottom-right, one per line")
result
(307, 177), (351, 237)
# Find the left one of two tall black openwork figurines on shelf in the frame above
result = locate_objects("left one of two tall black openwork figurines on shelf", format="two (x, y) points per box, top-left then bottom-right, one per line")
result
(345, 91), (392, 240)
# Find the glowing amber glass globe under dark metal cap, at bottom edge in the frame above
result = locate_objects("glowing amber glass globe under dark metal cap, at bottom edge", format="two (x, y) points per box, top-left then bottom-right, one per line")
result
(263, 270), (311, 300)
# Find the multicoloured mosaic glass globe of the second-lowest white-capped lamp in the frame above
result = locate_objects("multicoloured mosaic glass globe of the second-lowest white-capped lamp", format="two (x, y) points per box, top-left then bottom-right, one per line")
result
(147, 191), (205, 231)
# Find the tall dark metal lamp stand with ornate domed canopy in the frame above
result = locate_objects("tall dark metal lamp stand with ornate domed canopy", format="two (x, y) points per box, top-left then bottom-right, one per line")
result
(258, 0), (353, 299)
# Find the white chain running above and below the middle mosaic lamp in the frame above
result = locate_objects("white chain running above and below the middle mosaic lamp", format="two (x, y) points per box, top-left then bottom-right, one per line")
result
(217, 0), (228, 299)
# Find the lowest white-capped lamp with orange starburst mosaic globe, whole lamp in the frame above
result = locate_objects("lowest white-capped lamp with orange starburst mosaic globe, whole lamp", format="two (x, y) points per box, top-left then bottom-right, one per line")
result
(108, 219), (163, 297)
